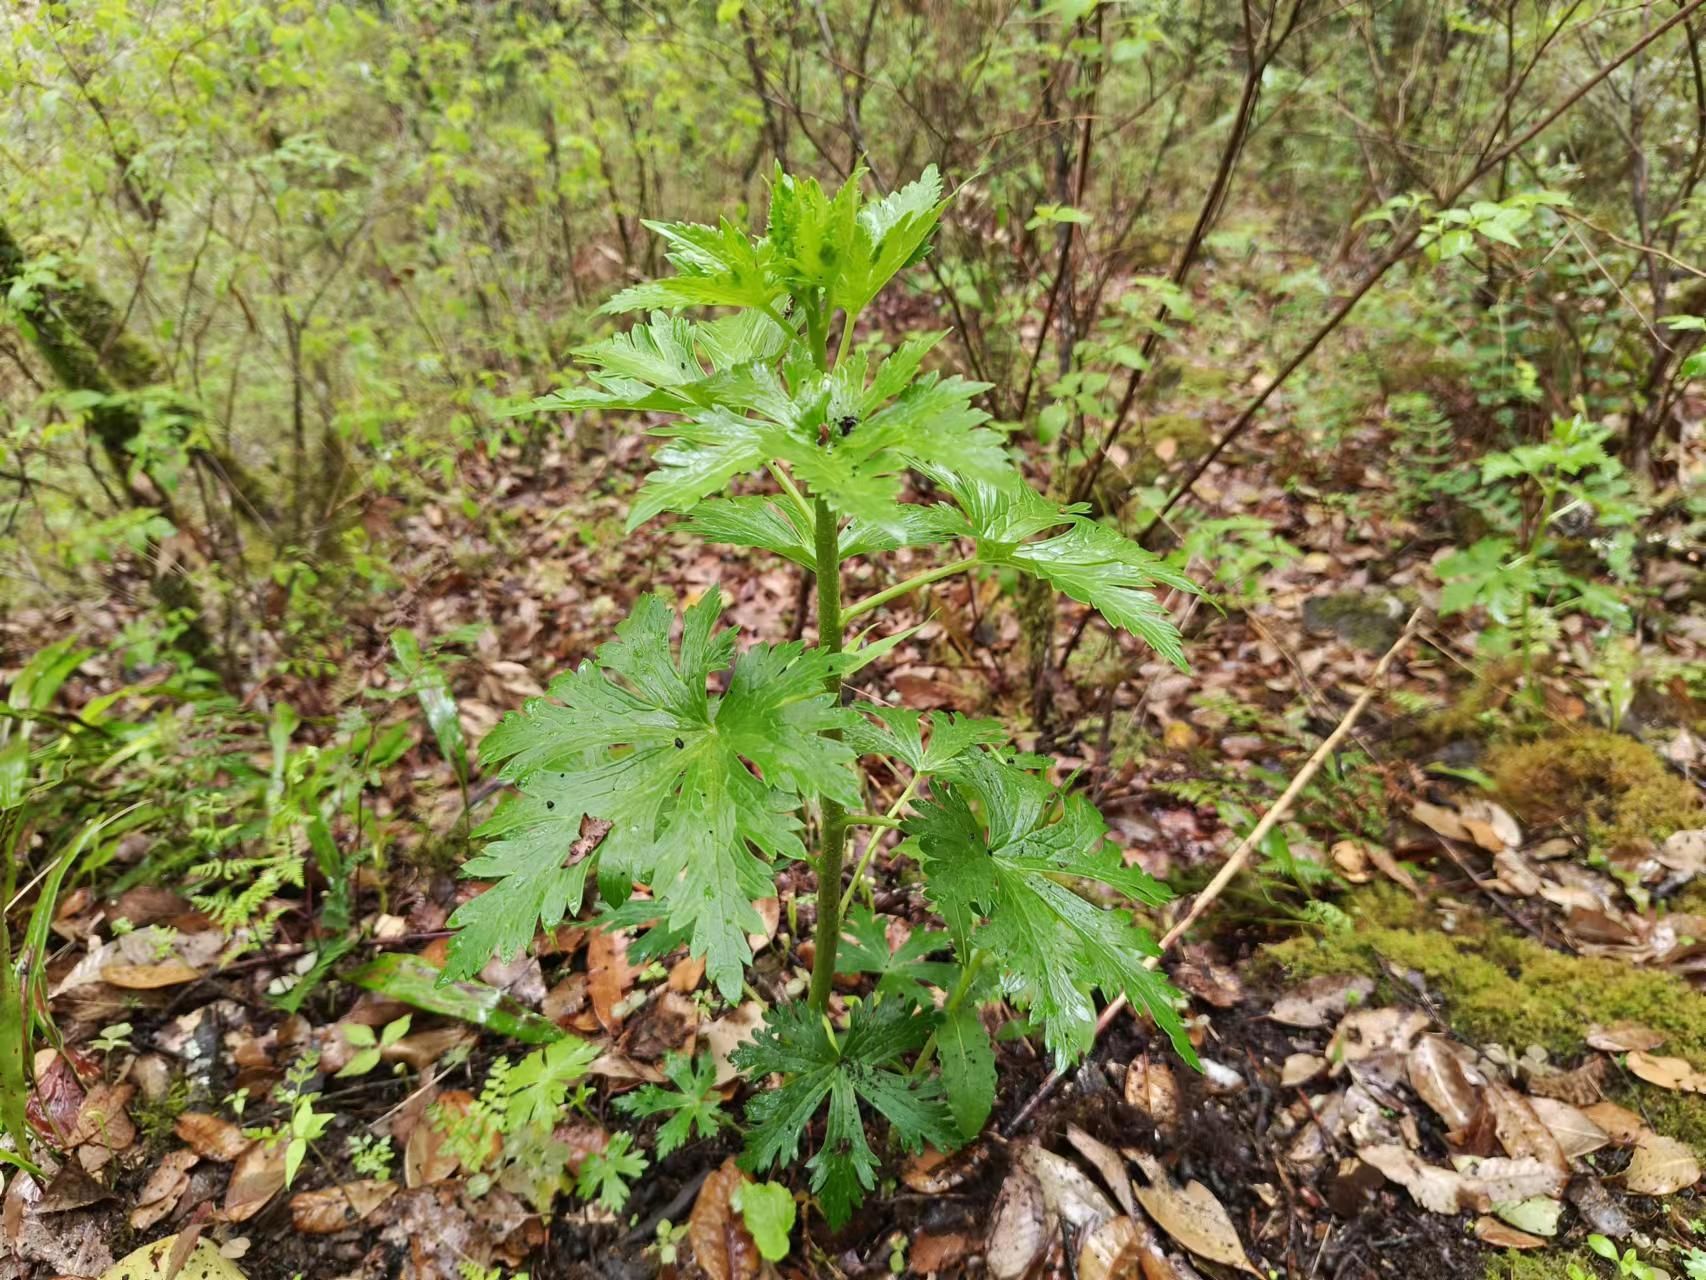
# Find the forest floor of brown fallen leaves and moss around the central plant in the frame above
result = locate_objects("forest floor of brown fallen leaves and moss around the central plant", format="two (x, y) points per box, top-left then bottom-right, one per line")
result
(10, 401), (1706, 1280)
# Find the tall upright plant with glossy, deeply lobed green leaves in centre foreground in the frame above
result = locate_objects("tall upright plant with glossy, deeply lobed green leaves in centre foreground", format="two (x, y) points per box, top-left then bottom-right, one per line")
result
(445, 169), (1194, 1224)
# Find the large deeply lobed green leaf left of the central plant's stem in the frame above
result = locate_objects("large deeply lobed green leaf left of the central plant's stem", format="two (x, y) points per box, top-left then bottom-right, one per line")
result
(445, 589), (860, 998)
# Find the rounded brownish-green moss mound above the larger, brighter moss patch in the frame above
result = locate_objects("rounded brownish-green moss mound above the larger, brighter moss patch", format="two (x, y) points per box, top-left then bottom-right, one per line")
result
(1488, 729), (1706, 852)
